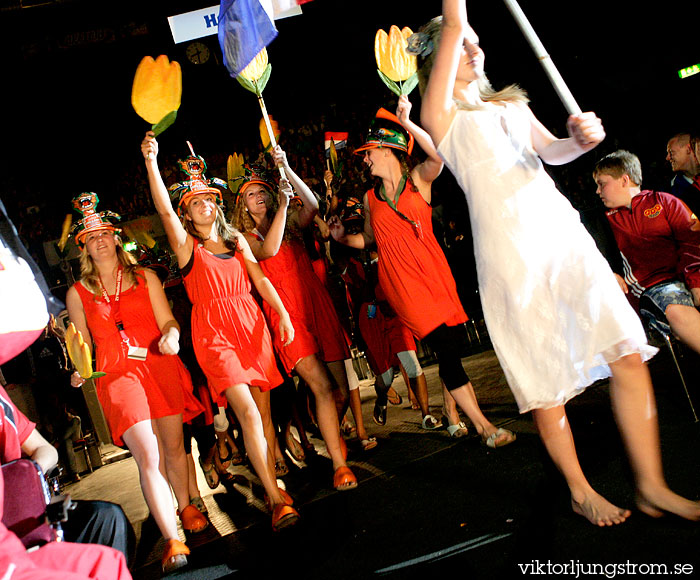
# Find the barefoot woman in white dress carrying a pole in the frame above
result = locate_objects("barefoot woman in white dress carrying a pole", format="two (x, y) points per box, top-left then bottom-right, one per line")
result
(416, 0), (700, 526)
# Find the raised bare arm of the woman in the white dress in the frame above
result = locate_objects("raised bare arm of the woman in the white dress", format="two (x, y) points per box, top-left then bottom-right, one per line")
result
(421, 0), (469, 143)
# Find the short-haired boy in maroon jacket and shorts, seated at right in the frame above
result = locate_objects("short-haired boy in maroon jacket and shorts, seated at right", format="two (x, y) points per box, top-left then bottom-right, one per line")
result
(593, 150), (700, 352)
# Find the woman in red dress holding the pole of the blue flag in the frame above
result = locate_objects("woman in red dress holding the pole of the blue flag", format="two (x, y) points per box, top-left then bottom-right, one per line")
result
(233, 153), (357, 490)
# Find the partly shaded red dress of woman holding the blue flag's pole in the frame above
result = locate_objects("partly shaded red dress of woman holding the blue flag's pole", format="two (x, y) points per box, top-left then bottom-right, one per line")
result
(255, 232), (350, 372)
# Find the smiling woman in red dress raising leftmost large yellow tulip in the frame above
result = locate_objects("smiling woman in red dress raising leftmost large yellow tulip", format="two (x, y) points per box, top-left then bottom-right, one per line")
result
(141, 131), (299, 530)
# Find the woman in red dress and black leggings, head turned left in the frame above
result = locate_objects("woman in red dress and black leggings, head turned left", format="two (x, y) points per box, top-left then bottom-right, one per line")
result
(329, 96), (515, 448)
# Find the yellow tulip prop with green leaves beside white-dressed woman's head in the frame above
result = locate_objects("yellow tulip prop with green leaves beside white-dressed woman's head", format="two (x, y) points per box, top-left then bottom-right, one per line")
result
(374, 25), (418, 96)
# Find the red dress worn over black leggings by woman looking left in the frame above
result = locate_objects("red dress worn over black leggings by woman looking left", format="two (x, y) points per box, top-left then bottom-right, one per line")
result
(367, 181), (467, 339)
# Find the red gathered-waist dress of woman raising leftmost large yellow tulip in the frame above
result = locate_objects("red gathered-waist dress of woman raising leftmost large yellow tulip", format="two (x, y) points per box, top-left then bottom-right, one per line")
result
(183, 241), (282, 399)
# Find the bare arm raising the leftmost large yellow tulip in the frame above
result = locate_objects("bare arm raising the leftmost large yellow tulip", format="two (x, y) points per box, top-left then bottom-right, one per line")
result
(141, 131), (193, 267)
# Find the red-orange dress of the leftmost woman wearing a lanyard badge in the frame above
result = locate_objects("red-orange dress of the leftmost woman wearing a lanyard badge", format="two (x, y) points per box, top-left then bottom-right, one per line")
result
(75, 278), (204, 445)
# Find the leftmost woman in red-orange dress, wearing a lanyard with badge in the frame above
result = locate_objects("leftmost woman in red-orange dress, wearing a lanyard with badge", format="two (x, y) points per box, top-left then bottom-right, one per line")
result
(66, 194), (207, 571)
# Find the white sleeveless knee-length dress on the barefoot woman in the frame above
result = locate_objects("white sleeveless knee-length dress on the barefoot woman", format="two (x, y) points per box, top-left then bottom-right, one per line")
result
(438, 104), (657, 413)
